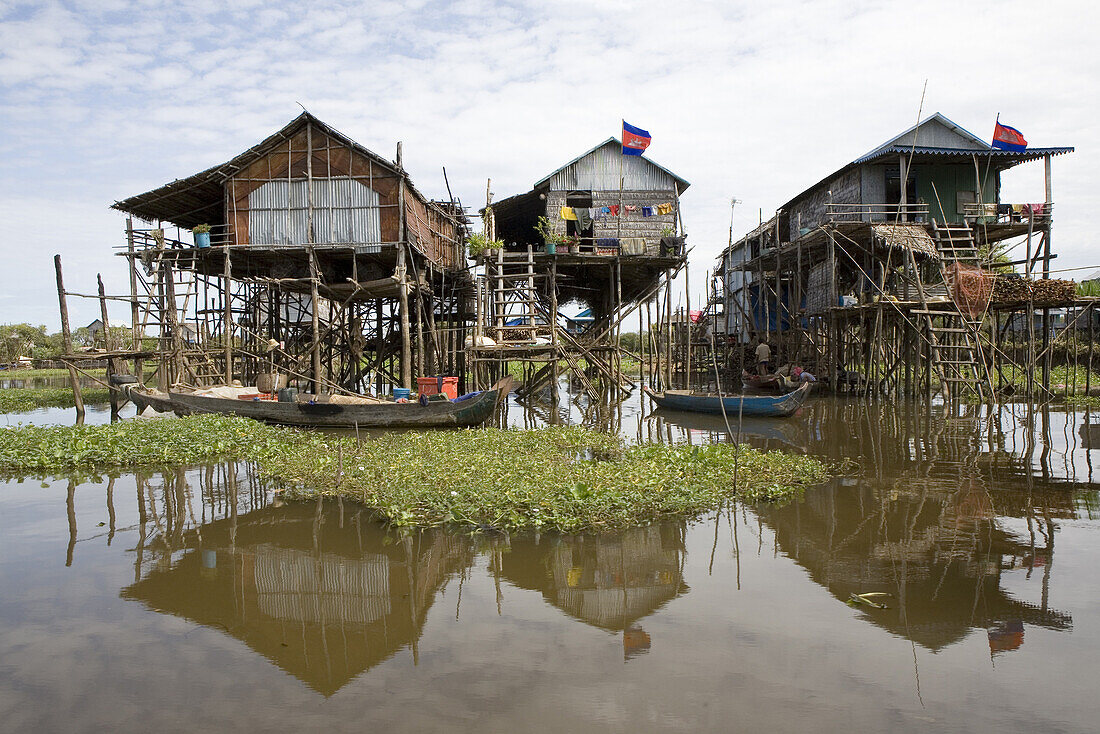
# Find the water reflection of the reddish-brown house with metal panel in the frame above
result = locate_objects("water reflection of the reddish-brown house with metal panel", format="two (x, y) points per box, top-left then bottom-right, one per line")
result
(122, 505), (472, 695)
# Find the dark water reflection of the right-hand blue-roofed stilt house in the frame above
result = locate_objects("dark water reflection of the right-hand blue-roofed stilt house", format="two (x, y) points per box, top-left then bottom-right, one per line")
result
(759, 476), (1073, 651)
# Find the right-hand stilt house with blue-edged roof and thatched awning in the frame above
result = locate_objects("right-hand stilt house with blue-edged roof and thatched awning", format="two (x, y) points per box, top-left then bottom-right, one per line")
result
(713, 112), (1074, 398)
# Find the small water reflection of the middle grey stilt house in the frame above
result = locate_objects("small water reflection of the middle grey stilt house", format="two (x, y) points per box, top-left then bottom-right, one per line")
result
(501, 524), (689, 658)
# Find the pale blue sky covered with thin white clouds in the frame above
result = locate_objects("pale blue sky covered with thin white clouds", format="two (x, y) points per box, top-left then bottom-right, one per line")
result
(0, 0), (1100, 330)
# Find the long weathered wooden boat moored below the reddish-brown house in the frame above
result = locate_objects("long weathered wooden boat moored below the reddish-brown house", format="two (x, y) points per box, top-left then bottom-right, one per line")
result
(171, 376), (514, 428)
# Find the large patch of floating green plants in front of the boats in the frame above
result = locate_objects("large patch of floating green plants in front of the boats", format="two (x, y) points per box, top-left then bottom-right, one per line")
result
(0, 416), (827, 532)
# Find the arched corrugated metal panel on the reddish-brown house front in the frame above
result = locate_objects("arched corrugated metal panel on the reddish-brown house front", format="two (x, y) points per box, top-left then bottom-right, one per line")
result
(249, 178), (382, 244)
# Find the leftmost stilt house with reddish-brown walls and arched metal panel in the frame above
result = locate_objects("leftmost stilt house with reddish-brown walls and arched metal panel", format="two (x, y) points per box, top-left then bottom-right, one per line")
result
(114, 112), (470, 387)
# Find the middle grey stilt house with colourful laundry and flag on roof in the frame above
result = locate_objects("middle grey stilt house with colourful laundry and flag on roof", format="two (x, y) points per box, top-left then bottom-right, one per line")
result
(473, 138), (689, 402)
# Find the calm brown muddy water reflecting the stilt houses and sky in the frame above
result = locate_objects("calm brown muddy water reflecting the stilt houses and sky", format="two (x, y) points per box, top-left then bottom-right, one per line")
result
(0, 398), (1100, 732)
